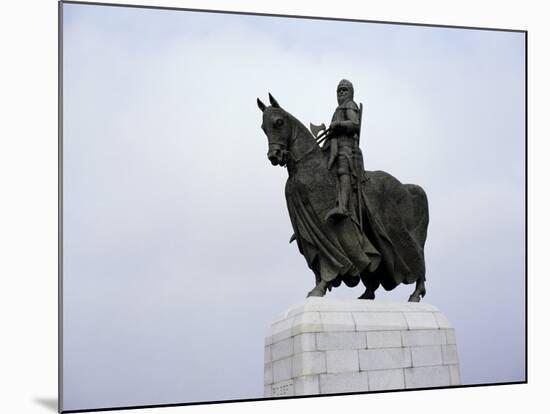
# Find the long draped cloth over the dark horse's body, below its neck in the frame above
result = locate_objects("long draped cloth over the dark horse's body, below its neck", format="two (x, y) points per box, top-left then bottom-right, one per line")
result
(285, 168), (428, 290)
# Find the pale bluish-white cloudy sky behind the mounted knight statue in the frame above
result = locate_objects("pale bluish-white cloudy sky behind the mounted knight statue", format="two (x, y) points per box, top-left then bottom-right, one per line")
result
(63, 4), (525, 409)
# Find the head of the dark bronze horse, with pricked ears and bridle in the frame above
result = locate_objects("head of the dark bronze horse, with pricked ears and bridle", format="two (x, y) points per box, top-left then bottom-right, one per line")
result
(257, 94), (293, 167)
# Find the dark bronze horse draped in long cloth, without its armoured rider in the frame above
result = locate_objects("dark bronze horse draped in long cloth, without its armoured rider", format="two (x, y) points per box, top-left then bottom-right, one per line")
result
(257, 94), (429, 302)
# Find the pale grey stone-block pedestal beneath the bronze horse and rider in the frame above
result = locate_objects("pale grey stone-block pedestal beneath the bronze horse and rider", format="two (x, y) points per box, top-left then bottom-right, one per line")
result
(264, 297), (460, 397)
